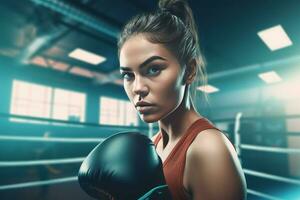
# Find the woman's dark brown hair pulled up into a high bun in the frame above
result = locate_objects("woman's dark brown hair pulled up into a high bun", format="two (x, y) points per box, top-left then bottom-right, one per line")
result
(118, 0), (207, 106)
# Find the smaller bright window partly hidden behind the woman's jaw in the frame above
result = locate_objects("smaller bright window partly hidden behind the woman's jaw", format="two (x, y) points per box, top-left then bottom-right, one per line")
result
(99, 97), (138, 126)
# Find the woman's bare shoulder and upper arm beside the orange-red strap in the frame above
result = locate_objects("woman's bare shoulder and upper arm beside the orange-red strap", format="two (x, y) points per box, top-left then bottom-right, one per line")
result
(184, 129), (246, 200)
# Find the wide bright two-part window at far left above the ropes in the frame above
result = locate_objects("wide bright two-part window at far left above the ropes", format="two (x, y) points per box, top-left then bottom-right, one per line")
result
(10, 80), (86, 123)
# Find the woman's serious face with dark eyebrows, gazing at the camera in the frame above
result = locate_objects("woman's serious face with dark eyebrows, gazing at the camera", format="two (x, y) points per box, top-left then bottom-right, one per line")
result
(120, 34), (185, 123)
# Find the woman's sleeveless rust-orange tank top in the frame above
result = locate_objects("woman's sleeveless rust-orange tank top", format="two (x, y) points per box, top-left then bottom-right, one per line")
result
(154, 118), (218, 200)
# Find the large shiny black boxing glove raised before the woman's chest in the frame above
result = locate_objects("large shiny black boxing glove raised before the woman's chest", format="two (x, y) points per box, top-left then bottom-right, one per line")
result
(78, 132), (170, 200)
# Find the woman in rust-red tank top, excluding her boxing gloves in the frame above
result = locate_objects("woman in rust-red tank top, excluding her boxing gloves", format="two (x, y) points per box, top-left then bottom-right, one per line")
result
(118, 0), (246, 200)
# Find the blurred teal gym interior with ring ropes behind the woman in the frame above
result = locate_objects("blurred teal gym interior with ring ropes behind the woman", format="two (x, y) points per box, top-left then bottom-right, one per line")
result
(0, 0), (300, 200)
